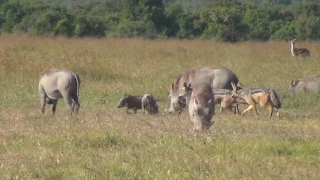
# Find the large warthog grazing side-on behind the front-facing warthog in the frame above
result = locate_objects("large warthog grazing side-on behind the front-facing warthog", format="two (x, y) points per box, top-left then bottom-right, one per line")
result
(168, 67), (242, 113)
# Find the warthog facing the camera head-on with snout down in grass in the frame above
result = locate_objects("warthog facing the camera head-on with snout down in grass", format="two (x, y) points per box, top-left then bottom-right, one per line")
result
(188, 83), (214, 131)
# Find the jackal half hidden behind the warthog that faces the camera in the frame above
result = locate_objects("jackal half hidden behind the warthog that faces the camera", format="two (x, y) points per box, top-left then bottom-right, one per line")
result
(180, 83), (239, 114)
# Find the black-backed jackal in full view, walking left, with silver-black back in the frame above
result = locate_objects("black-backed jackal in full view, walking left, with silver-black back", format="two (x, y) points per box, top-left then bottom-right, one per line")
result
(231, 83), (281, 118)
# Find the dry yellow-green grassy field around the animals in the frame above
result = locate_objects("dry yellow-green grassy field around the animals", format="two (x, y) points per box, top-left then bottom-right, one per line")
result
(0, 36), (320, 179)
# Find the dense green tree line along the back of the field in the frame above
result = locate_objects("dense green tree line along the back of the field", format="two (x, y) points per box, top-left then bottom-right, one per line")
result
(0, 0), (320, 42)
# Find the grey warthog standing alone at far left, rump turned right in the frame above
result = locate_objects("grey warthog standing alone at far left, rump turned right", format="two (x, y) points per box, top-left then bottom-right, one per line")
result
(38, 69), (80, 115)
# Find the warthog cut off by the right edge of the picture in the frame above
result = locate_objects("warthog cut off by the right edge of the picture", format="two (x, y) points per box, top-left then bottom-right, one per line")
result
(289, 75), (320, 95)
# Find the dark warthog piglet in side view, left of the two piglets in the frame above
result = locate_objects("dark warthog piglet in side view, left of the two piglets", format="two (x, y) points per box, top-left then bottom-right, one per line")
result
(118, 95), (142, 114)
